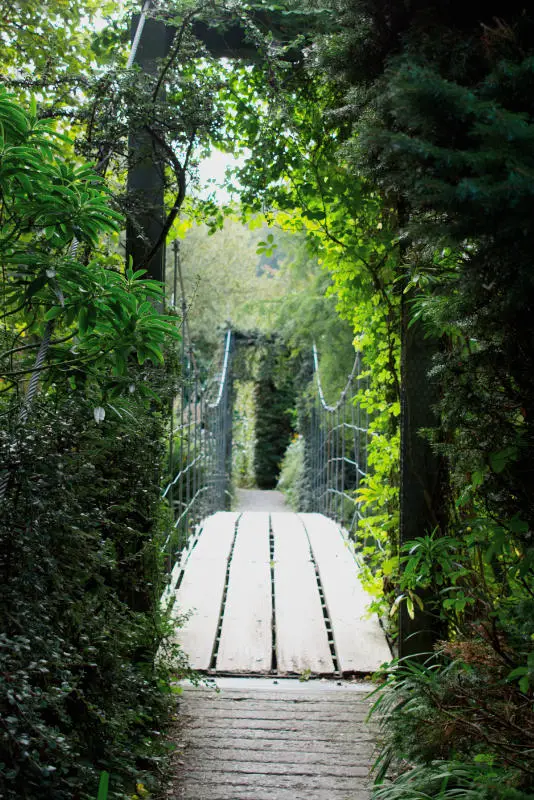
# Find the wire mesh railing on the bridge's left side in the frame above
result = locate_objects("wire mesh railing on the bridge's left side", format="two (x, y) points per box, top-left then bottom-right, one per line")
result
(163, 331), (233, 571)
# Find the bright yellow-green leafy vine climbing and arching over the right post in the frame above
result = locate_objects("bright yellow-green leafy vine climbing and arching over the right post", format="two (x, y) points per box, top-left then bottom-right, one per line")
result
(220, 43), (400, 611)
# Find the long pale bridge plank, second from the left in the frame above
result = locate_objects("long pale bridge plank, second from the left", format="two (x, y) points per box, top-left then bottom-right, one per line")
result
(216, 511), (272, 673)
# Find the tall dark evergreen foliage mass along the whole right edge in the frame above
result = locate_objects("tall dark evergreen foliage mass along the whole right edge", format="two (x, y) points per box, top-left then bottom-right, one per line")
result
(312, 0), (534, 800)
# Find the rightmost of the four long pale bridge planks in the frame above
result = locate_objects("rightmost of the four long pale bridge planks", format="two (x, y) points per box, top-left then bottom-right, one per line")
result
(299, 514), (391, 672)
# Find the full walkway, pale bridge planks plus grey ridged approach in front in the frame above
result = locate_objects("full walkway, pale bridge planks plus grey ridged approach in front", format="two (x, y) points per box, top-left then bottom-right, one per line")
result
(168, 510), (391, 800)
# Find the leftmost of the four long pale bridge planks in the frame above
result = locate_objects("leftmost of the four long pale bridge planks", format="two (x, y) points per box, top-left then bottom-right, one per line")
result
(173, 511), (238, 670)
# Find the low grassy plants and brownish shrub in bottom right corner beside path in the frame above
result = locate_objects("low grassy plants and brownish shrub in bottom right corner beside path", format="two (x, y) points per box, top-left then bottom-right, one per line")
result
(372, 648), (532, 800)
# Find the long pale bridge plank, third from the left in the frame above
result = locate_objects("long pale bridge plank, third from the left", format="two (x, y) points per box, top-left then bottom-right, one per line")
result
(271, 513), (334, 673)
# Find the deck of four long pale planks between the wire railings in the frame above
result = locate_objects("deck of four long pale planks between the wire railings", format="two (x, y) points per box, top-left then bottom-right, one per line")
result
(175, 511), (390, 676)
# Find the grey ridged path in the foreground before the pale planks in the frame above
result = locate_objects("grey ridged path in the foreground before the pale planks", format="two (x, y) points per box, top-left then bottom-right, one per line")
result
(167, 678), (373, 800)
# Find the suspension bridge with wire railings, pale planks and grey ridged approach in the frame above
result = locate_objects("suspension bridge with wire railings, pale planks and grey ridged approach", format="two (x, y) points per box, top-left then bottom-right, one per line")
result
(163, 331), (391, 800)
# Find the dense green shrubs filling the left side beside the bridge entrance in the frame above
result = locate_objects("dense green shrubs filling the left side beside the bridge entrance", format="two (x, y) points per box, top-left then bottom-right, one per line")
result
(0, 93), (185, 800)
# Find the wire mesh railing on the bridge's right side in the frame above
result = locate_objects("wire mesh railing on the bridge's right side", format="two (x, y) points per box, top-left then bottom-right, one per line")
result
(303, 345), (371, 534)
